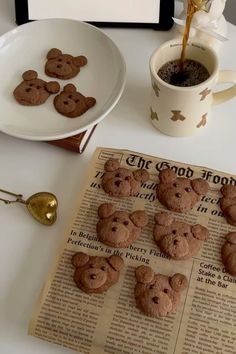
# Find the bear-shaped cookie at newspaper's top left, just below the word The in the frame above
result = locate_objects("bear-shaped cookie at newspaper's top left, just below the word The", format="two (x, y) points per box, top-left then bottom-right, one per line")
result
(102, 159), (149, 197)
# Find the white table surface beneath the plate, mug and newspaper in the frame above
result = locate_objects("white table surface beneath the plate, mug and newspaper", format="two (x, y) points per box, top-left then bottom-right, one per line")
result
(0, 0), (236, 354)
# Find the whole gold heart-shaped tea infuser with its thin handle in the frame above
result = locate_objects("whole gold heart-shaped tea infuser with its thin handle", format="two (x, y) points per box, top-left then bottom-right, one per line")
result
(0, 189), (58, 225)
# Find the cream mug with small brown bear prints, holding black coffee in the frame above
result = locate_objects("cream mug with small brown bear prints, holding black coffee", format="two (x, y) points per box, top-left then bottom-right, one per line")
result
(149, 39), (236, 136)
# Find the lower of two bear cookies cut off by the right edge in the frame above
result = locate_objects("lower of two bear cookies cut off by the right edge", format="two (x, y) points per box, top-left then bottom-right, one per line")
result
(221, 232), (236, 276)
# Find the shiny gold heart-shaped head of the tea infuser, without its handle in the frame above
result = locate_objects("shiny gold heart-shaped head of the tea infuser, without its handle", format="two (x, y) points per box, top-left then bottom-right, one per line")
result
(26, 192), (58, 225)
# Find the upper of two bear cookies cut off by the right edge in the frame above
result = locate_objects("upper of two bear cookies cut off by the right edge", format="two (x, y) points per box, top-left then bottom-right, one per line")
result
(220, 184), (236, 226)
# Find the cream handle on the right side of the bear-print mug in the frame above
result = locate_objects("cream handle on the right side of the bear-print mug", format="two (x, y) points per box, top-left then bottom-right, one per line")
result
(213, 70), (236, 105)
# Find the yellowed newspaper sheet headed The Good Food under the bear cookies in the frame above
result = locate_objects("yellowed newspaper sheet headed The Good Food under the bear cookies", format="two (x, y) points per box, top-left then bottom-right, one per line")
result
(29, 148), (236, 354)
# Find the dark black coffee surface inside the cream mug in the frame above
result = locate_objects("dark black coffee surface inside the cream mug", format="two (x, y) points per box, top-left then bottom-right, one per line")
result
(157, 59), (210, 87)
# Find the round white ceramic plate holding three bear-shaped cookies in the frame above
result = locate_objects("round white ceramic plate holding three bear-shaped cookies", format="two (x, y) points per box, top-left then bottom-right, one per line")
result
(0, 19), (126, 140)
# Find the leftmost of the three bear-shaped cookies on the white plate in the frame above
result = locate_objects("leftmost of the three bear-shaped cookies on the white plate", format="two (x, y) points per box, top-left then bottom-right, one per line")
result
(13, 70), (60, 106)
